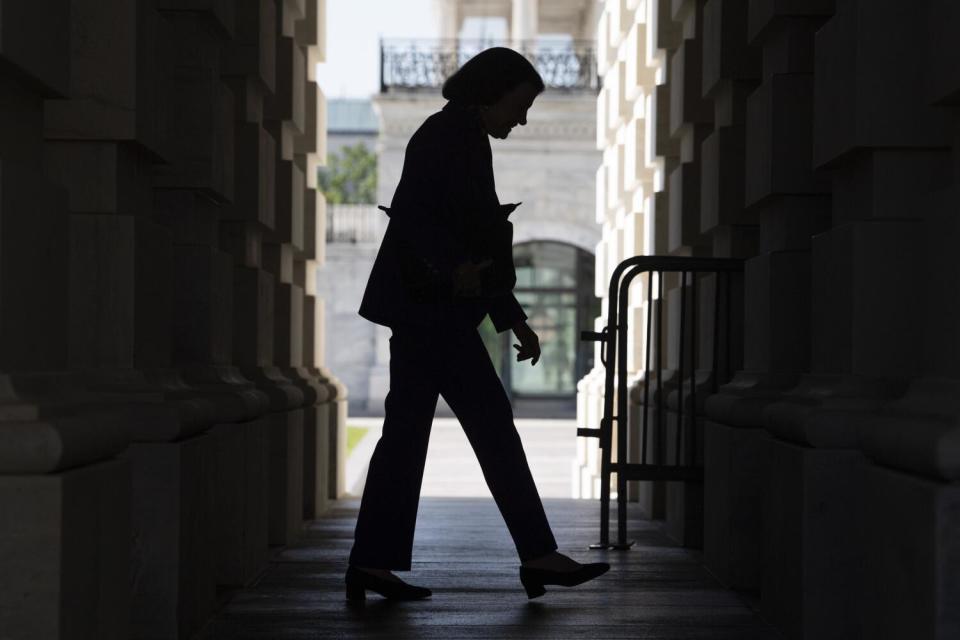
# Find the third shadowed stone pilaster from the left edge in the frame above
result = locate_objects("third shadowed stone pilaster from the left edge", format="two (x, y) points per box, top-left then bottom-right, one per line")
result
(148, 2), (278, 635)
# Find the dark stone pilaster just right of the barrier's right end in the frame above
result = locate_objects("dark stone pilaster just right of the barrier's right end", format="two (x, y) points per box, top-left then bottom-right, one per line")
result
(724, 2), (832, 628)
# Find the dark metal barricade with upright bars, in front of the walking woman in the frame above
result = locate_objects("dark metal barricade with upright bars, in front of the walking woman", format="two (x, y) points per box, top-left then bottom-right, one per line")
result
(577, 256), (743, 549)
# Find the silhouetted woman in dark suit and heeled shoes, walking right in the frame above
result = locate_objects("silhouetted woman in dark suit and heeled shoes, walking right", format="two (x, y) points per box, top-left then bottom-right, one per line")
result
(346, 47), (609, 599)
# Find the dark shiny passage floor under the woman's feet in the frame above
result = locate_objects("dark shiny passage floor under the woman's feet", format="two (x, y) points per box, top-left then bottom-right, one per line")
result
(200, 497), (780, 640)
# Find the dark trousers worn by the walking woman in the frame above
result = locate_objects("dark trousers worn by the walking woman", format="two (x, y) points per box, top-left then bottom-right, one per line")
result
(350, 325), (557, 571)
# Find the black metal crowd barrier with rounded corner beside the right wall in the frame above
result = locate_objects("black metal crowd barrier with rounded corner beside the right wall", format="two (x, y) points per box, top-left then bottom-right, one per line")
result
(577, 256), (743, 549)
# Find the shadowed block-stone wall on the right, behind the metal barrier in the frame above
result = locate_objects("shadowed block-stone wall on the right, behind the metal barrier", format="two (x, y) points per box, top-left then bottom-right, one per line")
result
(581, 0), (960, 638)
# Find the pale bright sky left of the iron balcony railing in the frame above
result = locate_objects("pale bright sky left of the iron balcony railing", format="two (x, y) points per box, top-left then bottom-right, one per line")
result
(317, 0), (439, 98)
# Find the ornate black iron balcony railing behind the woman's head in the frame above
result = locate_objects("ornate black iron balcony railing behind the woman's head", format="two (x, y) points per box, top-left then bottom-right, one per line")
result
(380, 39), (600, 93)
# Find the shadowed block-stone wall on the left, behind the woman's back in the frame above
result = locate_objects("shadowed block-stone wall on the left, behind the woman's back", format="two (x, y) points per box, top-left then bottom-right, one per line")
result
(0, 0), (345, 639)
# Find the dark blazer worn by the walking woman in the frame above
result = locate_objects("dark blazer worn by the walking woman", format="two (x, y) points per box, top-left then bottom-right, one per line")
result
(359, 102), (527, 332)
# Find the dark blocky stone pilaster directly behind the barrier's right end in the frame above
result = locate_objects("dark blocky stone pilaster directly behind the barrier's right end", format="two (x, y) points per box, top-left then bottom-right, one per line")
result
(697, 0), (763, 588)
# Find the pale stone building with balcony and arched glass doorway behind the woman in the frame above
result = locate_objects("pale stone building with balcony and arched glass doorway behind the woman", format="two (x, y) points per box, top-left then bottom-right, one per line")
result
(358, 0), (600, 417)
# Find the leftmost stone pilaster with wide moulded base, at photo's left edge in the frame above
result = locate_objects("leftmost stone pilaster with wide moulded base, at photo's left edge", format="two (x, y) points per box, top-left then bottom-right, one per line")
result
(0, 2), (130, 638)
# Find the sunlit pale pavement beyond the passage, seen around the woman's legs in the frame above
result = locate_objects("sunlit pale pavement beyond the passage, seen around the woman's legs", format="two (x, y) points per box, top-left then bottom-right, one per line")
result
(347, 418), (577, 498)
